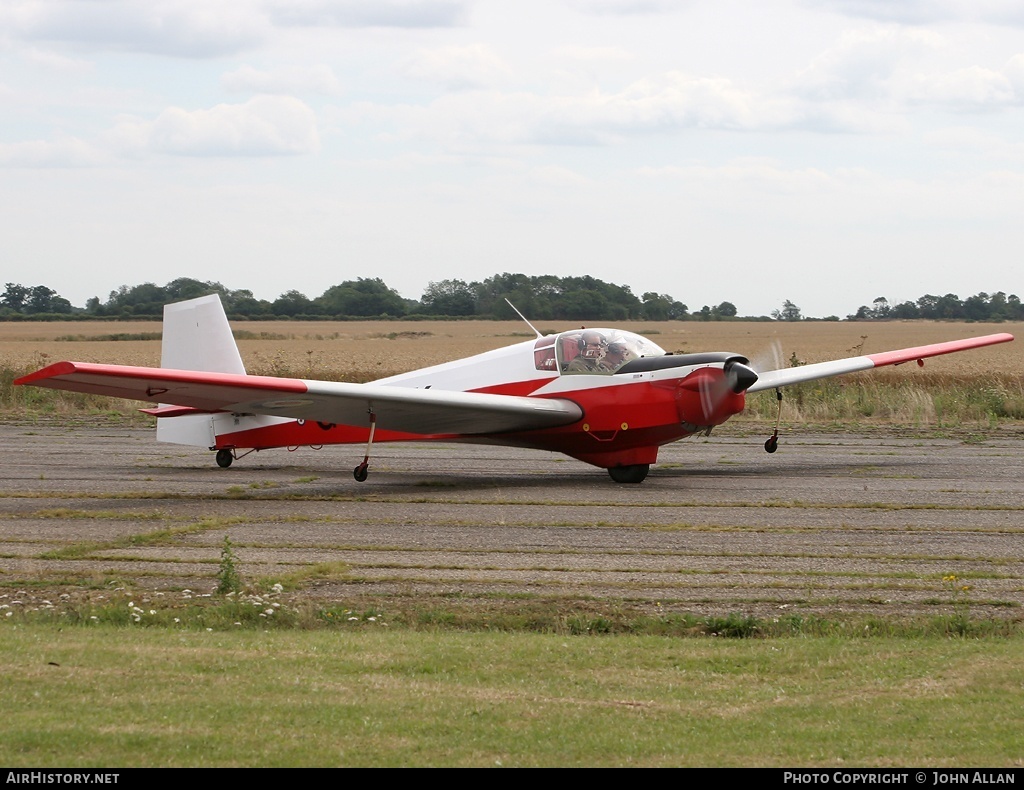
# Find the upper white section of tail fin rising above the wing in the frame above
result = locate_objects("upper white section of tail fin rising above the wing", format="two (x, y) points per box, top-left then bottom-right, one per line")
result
(160, 293), (246, 373)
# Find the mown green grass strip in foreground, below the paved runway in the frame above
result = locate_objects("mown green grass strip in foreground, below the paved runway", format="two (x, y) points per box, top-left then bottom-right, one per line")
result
(0, 624), (1024, 766)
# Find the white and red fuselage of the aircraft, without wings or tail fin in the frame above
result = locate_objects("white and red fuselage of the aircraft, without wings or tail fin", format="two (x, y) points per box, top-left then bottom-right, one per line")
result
(192, 329), (745, 467)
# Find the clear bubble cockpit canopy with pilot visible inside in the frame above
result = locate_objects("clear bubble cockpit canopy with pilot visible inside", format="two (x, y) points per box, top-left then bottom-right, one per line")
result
(534, 329), (665, 376)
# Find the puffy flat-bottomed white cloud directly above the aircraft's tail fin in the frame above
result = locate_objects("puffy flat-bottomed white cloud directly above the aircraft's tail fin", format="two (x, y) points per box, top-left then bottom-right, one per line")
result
(109, 96), (319, 157)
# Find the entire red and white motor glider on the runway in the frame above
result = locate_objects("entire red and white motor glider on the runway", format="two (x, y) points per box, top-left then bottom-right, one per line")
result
(14, 294), (1014, 483)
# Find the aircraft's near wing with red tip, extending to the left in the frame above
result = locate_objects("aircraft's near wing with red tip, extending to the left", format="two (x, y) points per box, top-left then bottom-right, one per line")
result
(14, 362), (583, 435)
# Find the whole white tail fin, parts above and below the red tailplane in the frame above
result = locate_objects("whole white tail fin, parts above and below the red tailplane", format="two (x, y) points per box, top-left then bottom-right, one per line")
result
(157, 294), (246, 448)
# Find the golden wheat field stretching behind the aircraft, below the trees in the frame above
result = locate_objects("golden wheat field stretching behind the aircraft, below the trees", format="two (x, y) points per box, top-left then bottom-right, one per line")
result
(0, 321), (1024, 381)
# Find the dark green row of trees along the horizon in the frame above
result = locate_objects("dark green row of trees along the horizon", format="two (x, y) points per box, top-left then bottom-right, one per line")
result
(0, 273), (1024, 322)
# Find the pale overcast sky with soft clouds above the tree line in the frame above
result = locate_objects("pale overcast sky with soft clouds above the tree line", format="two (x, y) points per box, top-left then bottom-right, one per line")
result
(0, 0), (1024, 318)
